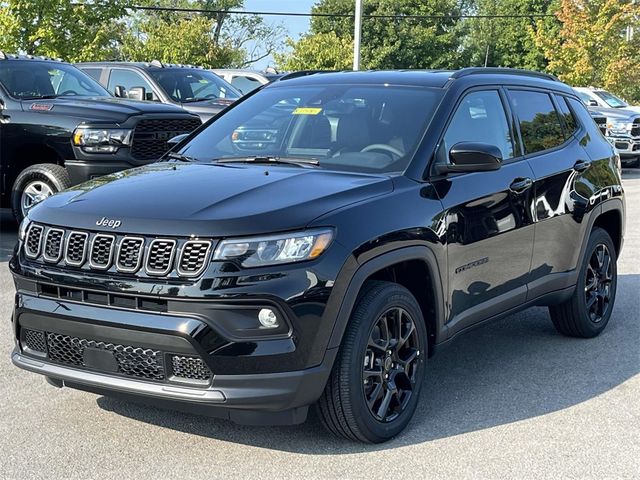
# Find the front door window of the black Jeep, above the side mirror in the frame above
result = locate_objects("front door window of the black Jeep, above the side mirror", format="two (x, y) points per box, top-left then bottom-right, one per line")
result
(444, 90), (513, 160)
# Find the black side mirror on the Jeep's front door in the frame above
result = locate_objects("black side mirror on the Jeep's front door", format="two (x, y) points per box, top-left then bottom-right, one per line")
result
(436, 142), (502, 173)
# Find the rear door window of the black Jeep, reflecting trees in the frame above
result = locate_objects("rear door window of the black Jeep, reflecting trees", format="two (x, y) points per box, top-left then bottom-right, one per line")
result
(510, 90), (565, 154)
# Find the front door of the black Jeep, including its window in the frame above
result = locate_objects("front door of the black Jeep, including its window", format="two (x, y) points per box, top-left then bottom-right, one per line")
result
(434, 88), (534, 335)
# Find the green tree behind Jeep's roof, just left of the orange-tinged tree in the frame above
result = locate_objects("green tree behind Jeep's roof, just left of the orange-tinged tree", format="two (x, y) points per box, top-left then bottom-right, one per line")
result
(464, 0), (558, 70)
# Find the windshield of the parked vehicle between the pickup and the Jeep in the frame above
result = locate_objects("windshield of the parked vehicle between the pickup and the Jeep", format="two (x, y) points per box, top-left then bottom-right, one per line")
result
(149, 68), (242, 103)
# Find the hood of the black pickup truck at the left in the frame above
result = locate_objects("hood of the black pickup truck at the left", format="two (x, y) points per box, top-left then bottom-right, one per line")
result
(22, 96), (192, 123)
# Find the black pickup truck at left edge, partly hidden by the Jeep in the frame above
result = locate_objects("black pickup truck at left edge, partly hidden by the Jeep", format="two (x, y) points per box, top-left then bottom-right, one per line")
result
(0, 52), (201, 220)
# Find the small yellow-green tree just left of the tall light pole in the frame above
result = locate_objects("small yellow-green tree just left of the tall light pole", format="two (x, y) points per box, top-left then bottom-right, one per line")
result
(275, 32), (353, 70)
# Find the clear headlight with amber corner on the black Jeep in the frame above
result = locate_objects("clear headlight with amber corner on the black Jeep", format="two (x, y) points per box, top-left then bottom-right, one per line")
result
(213, 230), (333, 267)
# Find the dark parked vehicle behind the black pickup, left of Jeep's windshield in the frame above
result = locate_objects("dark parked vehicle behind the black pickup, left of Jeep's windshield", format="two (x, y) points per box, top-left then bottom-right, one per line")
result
(77, 60), (242, 122)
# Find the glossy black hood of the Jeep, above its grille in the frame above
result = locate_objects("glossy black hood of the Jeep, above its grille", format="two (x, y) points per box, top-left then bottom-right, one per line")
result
(29, 162), (393, 237)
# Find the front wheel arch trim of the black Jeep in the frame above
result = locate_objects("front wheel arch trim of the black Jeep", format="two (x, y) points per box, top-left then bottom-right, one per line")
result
(327, 245), (444, 355)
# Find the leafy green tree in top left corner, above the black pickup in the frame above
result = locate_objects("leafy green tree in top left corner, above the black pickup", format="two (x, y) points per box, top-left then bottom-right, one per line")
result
(0, 0), (125, 62)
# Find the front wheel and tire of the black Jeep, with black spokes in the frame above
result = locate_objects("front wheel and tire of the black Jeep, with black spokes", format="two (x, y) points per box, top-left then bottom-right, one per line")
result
(316, 281), (428, 443)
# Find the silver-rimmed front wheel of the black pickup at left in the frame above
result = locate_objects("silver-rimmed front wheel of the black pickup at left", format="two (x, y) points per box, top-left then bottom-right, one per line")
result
(11, 163), (71, 223)
